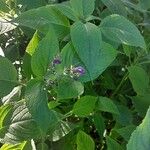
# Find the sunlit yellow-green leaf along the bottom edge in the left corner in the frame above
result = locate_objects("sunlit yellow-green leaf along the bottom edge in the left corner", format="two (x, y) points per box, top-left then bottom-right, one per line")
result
(0, 142), (32, 150)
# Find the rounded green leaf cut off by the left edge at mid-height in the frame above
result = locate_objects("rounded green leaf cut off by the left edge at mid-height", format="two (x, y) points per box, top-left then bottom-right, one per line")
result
(0, 56), (18, 98)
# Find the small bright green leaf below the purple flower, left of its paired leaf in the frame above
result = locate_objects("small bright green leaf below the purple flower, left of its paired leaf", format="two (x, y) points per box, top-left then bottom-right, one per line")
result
(72, 96), (97, 117)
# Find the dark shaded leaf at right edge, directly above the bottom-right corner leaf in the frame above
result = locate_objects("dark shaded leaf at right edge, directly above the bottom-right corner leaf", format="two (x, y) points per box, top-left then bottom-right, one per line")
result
(131, 94), (150, 117)
